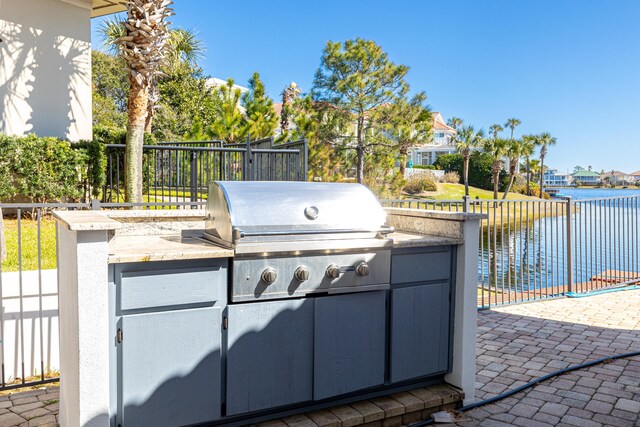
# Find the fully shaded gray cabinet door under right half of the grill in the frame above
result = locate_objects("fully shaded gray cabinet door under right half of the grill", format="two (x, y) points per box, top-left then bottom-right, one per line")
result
(313, 291), (385, 400)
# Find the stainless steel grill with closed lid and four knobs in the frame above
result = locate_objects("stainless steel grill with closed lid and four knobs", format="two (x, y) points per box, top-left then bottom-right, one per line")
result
(205, 182), (392, 302)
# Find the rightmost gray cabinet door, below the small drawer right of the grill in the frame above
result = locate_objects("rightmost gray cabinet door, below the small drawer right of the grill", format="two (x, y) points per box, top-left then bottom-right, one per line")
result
(391, 282), (450, 382)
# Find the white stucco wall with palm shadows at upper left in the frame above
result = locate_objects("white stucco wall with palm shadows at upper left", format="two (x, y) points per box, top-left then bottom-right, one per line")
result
(0, 0), (91, 141)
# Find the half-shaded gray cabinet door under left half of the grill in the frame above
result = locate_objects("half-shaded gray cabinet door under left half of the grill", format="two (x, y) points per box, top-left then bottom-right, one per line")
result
(227, 299), (313, 415)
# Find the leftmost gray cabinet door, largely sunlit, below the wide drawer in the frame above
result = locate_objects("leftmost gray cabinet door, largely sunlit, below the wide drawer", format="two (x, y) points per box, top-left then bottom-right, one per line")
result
(119, 307), (222, 426)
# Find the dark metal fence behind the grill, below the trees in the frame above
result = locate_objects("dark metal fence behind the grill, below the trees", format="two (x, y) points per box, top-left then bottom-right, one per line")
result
(101, 138), (308, 203)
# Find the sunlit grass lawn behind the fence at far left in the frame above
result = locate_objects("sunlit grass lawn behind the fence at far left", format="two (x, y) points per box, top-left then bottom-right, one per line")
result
(2, 217), (56, 272)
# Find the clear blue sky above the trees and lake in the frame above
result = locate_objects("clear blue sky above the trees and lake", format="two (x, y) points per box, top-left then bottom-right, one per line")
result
(92, 0), (640, 172)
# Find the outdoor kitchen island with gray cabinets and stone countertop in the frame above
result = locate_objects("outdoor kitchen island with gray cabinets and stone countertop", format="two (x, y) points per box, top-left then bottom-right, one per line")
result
(56, 183), (479, 426)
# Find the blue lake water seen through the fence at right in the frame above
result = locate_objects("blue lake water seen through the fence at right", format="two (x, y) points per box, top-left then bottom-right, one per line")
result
(479, 188), (640, 299)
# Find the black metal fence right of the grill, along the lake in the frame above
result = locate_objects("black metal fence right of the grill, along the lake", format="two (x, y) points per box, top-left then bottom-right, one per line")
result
(384, 196), (640, 308)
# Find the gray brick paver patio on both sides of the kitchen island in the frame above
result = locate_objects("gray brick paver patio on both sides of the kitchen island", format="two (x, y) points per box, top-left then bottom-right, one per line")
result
(0, 290), (640, 427)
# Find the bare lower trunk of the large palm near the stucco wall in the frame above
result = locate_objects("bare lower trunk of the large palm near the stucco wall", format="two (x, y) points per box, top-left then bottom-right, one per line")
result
(125, 78), (149, 203)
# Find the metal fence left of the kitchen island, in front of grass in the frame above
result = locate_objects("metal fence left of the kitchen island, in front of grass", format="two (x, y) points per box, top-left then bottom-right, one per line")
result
(0, 200), (206, 390)
